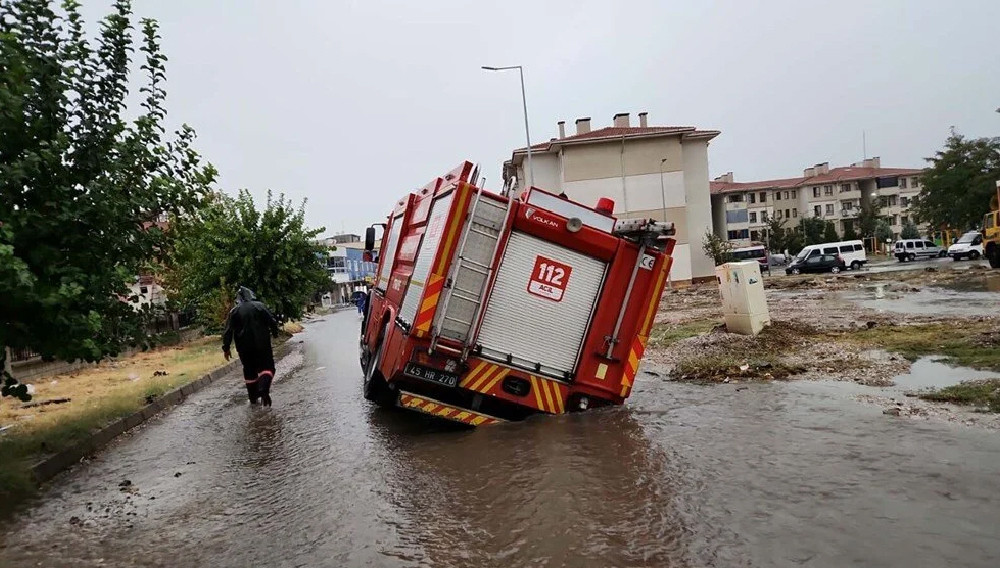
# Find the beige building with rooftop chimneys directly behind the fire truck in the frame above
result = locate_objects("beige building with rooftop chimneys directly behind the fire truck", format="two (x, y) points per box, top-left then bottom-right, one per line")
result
(504, 112), (719, 282)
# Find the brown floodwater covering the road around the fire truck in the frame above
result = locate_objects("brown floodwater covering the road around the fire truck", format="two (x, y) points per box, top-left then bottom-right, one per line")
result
(0, 312), (1000, 568)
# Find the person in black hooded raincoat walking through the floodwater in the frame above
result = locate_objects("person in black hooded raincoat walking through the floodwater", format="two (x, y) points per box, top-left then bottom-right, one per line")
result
(222, 286), (278, 406)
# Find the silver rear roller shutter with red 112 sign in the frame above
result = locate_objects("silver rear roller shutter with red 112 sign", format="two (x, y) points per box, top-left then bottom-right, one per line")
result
(477, 231), (607, 377)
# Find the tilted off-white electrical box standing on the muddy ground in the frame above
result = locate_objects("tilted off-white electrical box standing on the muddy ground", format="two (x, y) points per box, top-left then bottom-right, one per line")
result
(715, 261), (771, 335)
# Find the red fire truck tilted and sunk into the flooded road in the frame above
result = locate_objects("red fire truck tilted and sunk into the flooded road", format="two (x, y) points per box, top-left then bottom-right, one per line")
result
(360, 162), (674, 426)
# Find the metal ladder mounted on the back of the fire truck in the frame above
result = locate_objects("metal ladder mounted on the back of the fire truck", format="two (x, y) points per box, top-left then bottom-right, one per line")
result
(429, 188), (514, 361)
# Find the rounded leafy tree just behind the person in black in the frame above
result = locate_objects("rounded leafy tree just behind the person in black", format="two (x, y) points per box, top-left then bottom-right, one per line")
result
(167, 190), (329, 328)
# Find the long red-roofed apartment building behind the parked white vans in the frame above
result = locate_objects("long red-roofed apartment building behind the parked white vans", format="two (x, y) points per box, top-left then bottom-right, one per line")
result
(711, 157), (922, 244)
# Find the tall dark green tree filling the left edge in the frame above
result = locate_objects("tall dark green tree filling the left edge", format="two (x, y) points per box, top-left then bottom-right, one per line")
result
(0, 0), (215, 398)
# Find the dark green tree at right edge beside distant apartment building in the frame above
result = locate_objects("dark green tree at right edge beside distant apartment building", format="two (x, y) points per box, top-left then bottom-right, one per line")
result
(911, 130), (1000, 230)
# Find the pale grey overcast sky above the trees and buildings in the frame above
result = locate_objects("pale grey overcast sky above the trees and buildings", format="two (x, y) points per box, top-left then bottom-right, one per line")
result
(83, 0), (1000, 234)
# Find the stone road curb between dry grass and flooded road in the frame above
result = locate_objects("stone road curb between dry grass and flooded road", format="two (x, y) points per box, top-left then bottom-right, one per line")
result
(31, 340), (291, 484)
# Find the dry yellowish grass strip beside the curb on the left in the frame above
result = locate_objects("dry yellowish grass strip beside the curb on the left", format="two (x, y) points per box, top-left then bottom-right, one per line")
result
(0, 337), (224, 514)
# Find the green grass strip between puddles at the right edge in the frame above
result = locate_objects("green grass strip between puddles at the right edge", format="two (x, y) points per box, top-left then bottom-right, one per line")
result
(841, 321), (1000, 371)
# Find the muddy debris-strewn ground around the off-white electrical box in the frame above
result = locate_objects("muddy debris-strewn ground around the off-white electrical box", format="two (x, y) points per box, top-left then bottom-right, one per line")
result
(646, 269), (1000, 386)
